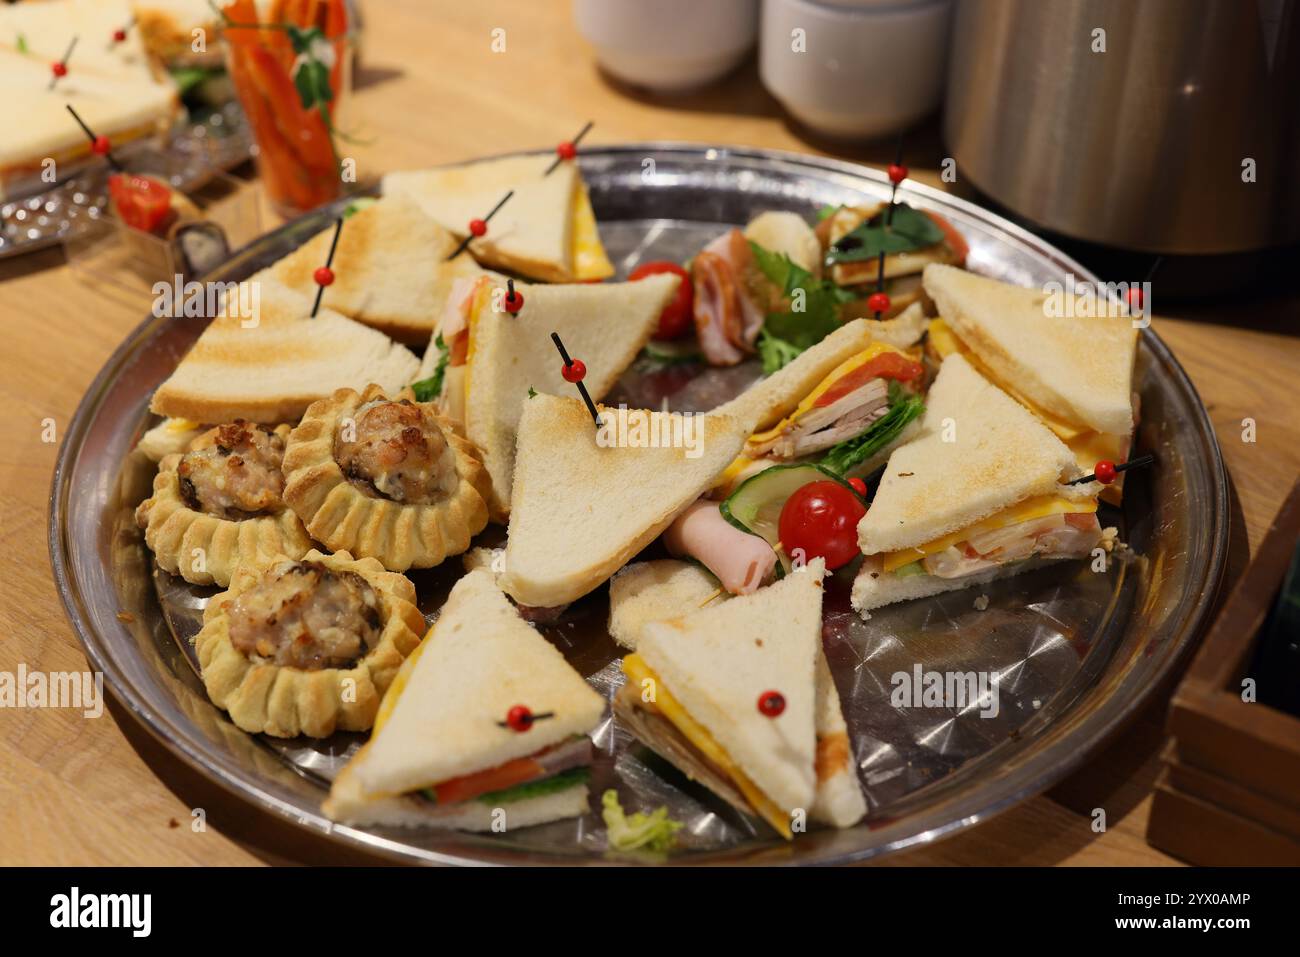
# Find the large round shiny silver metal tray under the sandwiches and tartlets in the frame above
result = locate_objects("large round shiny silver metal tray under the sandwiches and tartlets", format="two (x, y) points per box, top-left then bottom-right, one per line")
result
(49, 143), (1229, 863)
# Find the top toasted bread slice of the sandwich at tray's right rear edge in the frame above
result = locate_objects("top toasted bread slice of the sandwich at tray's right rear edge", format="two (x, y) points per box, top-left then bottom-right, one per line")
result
(924, 265), (1138, 436)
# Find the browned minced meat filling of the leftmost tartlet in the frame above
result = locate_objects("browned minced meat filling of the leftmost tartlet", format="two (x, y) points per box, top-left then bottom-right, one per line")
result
(176, 419), (285, 519)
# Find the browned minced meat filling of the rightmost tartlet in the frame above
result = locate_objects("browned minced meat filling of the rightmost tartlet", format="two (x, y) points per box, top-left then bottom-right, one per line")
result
(334, 399), (458, 505)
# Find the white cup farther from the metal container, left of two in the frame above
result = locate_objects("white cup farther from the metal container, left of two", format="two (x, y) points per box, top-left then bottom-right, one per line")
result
(573, 0), (758, 92)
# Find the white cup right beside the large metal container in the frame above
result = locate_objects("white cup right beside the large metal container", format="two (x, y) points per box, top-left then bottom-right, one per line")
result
(758, 0), (952, 138)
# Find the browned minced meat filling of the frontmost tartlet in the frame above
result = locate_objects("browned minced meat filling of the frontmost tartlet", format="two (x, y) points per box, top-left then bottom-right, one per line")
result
(226, 562), (382, 671)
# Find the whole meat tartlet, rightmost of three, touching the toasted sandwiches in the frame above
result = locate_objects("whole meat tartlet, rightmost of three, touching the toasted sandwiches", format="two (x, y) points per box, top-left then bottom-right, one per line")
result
(285, 385), (489, 571)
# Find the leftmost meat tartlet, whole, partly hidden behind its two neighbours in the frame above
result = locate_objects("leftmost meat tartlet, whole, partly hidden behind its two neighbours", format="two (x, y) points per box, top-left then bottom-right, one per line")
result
(135, 419), (312, 586)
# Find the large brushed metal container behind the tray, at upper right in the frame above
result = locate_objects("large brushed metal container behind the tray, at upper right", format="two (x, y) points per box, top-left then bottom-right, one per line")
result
(944, 0), (1300, 254)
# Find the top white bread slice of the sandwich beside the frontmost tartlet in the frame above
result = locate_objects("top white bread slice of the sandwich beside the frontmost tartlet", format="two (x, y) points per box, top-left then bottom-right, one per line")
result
(351, 571), (605, 796)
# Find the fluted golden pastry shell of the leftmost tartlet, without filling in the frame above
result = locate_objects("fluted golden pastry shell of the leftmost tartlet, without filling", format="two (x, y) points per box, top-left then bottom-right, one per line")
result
(135, 425), (312, 588)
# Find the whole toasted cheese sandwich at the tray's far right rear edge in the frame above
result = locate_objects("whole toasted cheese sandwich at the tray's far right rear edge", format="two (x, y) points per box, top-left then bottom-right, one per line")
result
(924, 265), (1138, 501)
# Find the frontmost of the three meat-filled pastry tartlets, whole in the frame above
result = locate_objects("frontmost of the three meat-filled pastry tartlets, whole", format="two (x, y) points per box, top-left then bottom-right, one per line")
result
(194, 549), (424, 737)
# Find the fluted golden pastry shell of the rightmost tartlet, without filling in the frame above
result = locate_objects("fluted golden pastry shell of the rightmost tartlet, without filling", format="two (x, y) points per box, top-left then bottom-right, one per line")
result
(283, 385), (488, 571)
